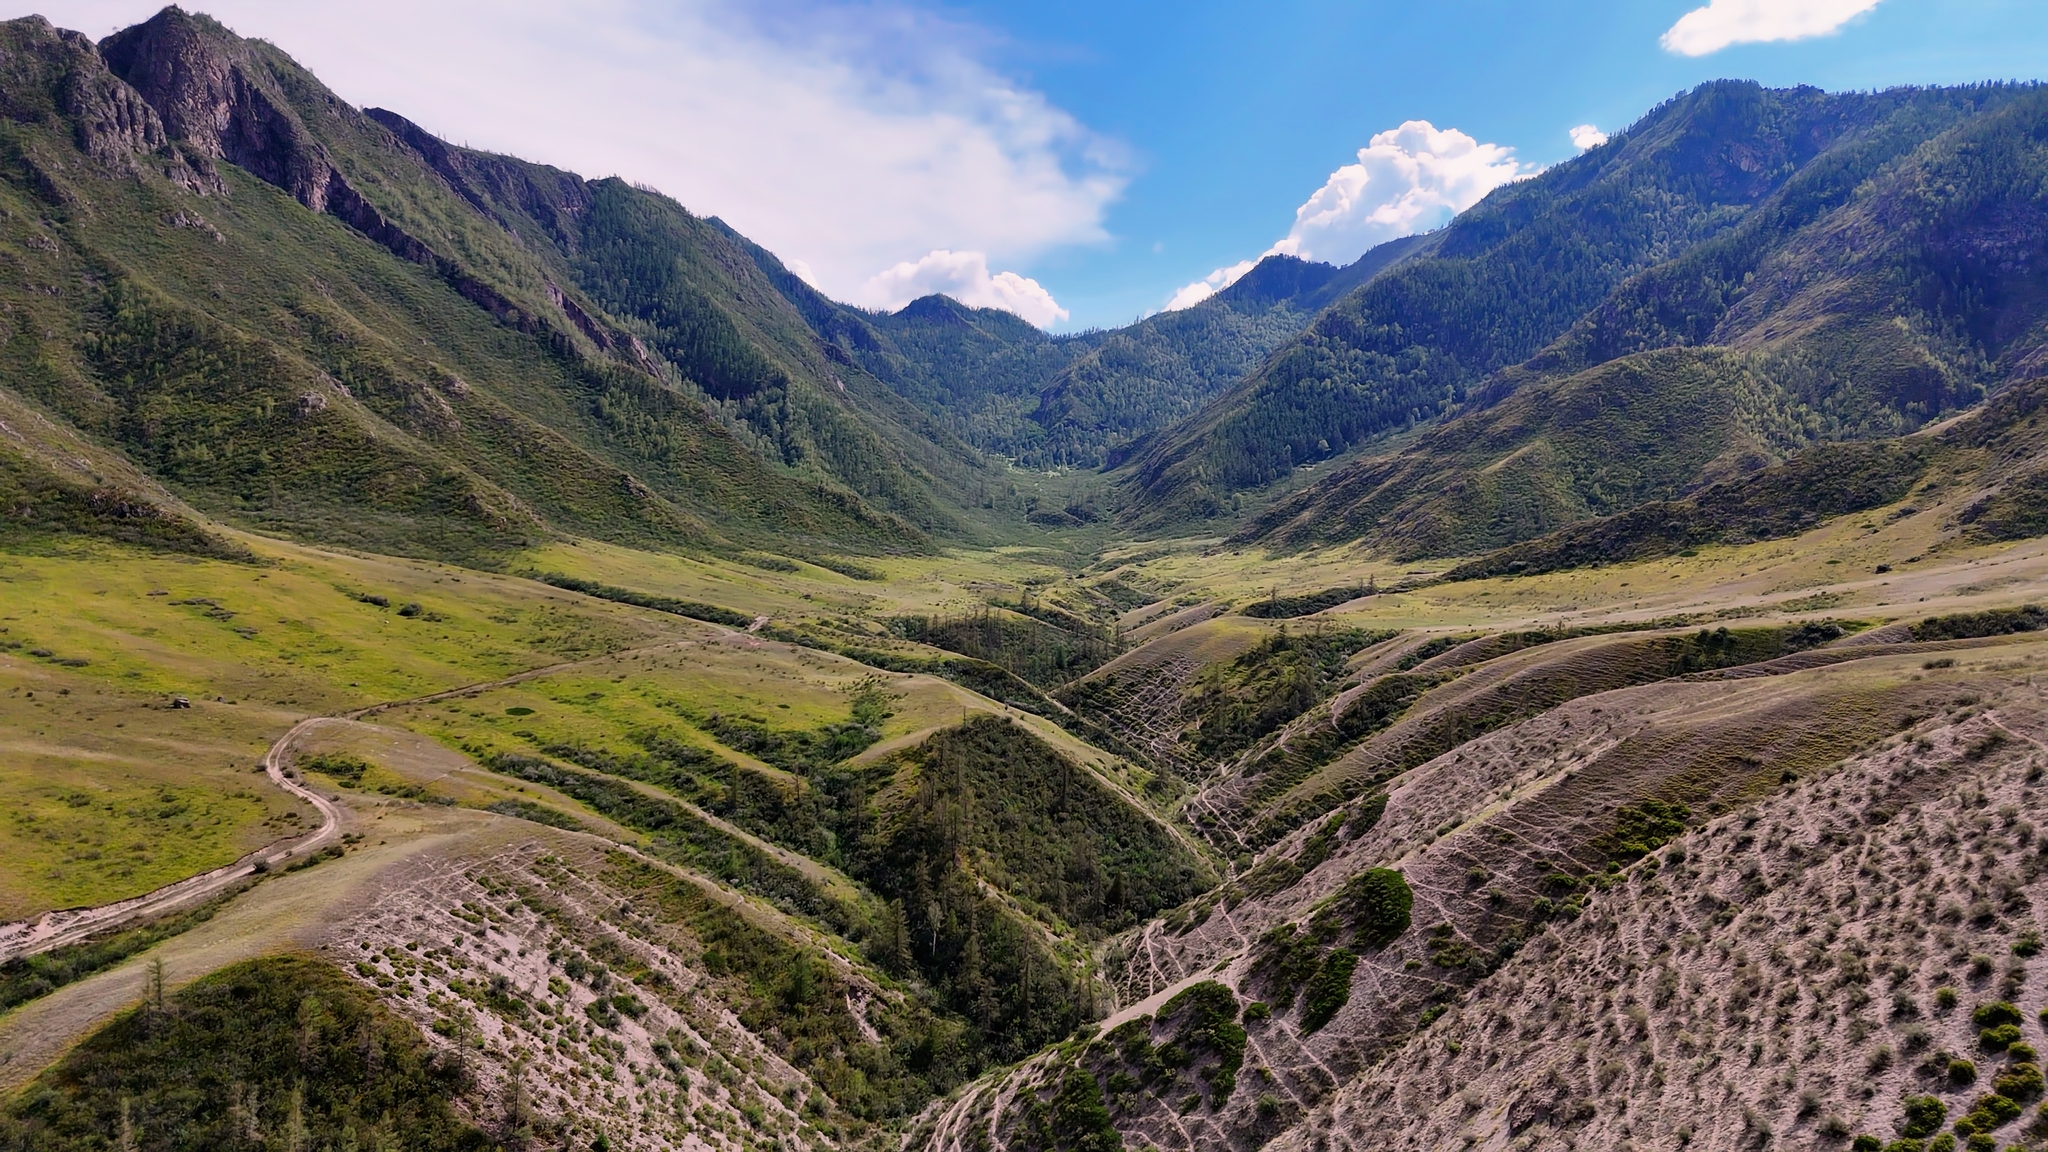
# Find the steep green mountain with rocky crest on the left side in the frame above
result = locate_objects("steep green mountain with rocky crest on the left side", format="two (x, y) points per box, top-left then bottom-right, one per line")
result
(0, 8), (1022, 558)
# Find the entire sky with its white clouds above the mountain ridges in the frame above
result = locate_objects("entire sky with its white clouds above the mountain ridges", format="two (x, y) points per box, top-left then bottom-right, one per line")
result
(28, 0), (2048, 330)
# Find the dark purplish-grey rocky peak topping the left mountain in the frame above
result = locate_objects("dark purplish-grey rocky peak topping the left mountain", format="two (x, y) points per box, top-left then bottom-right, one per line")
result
(98, 6), (336, 211)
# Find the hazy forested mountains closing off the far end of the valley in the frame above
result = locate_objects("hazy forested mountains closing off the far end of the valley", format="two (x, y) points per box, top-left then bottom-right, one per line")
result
(748, 242), (1413, 469)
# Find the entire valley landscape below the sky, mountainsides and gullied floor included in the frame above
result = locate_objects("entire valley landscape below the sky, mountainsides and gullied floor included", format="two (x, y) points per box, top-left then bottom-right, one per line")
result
(0, 8), (2048, 1152)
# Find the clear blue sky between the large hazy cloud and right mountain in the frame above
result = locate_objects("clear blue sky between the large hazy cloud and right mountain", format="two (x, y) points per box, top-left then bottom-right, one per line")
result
(958, 0), (2048, 324)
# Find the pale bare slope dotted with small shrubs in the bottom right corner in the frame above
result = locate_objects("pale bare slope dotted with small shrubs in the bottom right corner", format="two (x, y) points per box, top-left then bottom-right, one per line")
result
(1274, 668), (2044, 1150)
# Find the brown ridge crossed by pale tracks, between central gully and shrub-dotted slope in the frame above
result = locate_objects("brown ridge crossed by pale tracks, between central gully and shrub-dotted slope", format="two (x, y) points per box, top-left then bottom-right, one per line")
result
(920, 627), (2042, 1148)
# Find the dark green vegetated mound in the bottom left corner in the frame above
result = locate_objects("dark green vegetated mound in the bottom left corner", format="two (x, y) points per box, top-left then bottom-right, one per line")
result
(0, 957), (494, 1152)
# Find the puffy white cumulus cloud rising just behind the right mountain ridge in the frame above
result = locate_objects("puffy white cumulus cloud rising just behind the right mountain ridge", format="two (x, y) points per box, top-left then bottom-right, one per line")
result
(1165, 121), (1531, 312)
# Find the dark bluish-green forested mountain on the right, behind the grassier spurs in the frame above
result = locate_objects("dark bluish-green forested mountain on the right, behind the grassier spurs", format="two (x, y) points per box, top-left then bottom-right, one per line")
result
(1126, 82), (2038, 528)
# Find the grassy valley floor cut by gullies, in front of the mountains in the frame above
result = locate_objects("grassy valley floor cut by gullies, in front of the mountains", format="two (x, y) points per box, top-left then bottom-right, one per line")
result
(0, 500), (2048, 1152)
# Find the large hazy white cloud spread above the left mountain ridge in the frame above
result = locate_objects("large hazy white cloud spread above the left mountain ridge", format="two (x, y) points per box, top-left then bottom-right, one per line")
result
(32, 0), (1128, 312)
